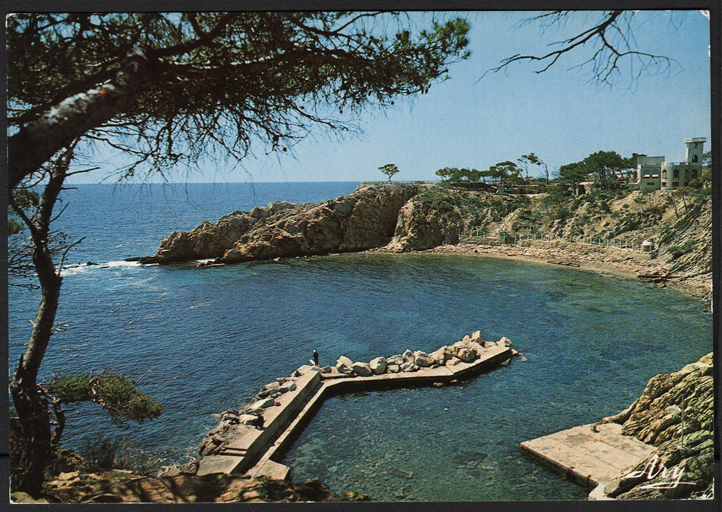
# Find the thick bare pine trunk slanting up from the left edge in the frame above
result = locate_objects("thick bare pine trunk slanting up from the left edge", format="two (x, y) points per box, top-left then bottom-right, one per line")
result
(8, 50), (159, 190)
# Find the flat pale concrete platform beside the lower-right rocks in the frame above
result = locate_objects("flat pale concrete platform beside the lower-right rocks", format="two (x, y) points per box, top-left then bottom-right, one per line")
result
(519, 423), (655, 491)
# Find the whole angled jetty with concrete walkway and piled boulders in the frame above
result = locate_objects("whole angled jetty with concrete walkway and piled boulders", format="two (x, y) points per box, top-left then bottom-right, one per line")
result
(165, 331), (519, 479)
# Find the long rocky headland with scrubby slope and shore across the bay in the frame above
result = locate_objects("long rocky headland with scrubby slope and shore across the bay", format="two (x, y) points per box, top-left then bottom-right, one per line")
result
(133, 184), (712, 300)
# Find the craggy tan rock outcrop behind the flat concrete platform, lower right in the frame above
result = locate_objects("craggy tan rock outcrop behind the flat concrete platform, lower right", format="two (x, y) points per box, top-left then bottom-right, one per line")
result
(603, 353), (714, 500)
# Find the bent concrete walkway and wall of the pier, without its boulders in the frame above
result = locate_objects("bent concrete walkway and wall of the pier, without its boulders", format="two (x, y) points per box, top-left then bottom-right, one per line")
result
(198, 346), (512, 479)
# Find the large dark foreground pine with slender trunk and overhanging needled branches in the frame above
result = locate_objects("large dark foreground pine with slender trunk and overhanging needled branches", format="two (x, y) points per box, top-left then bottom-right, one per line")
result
(6, 12), (469, 494)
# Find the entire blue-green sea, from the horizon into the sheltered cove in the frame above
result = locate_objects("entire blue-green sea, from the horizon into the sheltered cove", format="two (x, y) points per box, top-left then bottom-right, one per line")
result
(8, 182), (712, 502)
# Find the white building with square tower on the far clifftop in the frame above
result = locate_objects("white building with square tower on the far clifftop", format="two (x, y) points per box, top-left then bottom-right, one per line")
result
(636, 137), (707, 190)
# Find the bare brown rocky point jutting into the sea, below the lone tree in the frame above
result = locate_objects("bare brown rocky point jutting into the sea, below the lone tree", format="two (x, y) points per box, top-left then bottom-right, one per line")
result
(140, 184), (419, 263)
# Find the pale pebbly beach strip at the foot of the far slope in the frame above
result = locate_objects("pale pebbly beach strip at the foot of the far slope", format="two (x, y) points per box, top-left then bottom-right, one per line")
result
(368, 243), (712, 305)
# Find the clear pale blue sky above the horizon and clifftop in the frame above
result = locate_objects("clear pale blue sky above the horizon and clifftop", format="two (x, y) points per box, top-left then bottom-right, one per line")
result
(64, 11), (711, 183)
